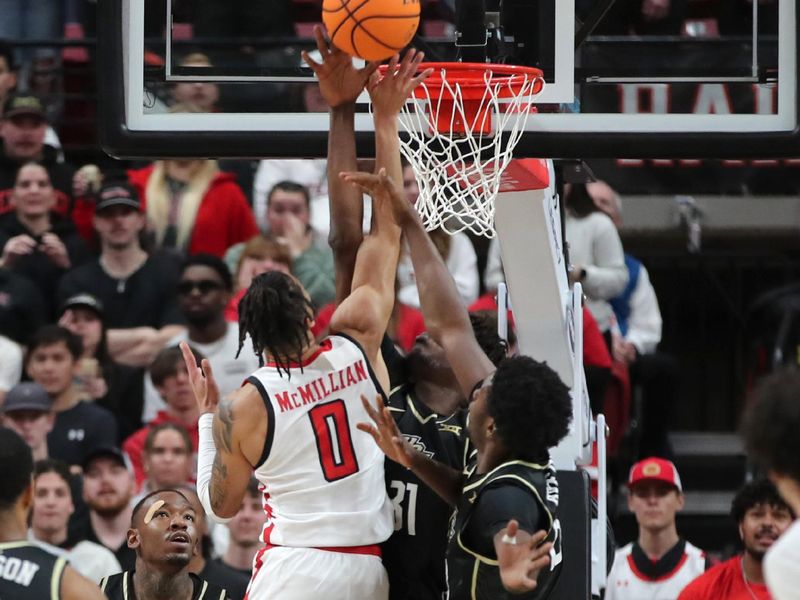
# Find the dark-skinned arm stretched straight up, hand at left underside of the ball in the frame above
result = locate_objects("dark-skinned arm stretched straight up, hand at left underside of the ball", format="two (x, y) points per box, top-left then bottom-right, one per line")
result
(303, 26), (378, 305)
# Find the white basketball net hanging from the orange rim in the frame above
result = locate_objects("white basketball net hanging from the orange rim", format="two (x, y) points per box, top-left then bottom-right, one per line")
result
(378, 66), (540, 238)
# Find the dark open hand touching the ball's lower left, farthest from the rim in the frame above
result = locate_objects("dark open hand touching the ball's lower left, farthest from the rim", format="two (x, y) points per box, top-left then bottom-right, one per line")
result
(301, 25), (378, 108)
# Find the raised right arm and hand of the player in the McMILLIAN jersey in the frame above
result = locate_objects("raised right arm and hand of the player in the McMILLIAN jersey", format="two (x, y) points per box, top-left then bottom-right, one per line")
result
(331, 49), (429, 389)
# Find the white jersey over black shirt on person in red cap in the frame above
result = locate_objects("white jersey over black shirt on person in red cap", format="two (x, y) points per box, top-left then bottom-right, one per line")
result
(605, 542), (706, 600)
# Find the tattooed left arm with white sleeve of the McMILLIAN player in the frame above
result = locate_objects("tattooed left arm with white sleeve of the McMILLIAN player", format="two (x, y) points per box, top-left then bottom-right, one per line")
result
(180, 342), (260, 523)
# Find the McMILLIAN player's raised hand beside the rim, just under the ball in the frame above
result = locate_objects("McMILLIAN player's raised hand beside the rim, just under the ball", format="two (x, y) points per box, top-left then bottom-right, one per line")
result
(367, 48), (433, 117)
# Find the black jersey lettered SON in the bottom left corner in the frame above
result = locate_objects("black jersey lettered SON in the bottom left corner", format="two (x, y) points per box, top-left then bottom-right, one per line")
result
(0, 541), (67, 600)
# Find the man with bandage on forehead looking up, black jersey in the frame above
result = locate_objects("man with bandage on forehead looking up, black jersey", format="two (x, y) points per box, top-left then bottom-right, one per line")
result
(100, 490), (227, 600)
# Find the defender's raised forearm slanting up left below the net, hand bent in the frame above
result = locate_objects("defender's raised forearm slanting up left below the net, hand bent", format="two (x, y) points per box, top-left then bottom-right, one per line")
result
(344, 173), (495, 397)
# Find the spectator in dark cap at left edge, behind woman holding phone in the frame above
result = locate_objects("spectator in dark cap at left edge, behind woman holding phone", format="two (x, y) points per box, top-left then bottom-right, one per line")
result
(0, 94), (75, 216)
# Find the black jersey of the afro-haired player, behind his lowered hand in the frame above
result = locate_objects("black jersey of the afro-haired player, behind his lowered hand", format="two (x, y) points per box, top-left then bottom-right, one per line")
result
(447, 455), (561, 600)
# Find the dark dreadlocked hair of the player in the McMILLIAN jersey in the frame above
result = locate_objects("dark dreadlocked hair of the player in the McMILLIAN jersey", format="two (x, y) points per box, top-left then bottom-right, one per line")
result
(236, 271), (314, 377)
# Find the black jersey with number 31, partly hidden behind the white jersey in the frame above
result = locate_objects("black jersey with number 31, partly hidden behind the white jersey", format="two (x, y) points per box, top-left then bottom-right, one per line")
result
(382, 386), (466, 600)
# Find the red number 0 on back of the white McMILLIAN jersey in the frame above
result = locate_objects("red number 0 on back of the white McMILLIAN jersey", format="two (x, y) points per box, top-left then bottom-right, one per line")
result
(308, 400), (358, 481)
